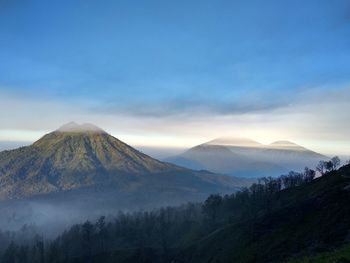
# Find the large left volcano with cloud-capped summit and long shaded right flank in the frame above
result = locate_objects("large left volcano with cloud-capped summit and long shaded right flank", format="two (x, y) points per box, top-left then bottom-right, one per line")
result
(0, 123), (249, 200)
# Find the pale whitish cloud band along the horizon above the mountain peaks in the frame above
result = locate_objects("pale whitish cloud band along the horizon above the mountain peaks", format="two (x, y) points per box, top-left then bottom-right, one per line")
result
(0, 87), (350, 156)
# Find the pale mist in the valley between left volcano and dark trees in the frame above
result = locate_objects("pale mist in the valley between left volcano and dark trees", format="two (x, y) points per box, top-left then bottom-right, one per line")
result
(0, 189), (213, 238)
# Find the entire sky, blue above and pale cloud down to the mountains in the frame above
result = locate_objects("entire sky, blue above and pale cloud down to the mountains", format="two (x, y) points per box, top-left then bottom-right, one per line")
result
(0, 0), (350, 155)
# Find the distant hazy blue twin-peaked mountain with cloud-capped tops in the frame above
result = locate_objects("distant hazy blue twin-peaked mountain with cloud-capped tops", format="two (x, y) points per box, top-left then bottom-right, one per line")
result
(166, 137), (327, 177)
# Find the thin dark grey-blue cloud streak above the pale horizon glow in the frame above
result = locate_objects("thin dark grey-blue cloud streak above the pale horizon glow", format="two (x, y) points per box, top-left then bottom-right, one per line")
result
(91, 94), (287, 118)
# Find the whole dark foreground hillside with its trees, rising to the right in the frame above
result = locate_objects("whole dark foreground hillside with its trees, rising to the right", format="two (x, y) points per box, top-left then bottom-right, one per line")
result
(3, 165), (350, 263)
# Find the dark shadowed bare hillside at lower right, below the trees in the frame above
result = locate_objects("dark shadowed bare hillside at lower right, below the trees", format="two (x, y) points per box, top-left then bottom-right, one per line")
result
(180, 165), (350, 263)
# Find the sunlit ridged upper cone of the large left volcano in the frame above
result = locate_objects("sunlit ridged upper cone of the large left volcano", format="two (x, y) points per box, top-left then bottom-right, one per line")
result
(0, 124), (171, 199)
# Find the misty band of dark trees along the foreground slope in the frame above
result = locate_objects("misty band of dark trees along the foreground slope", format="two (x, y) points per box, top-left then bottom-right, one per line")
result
(0, 157), (340, 263)
